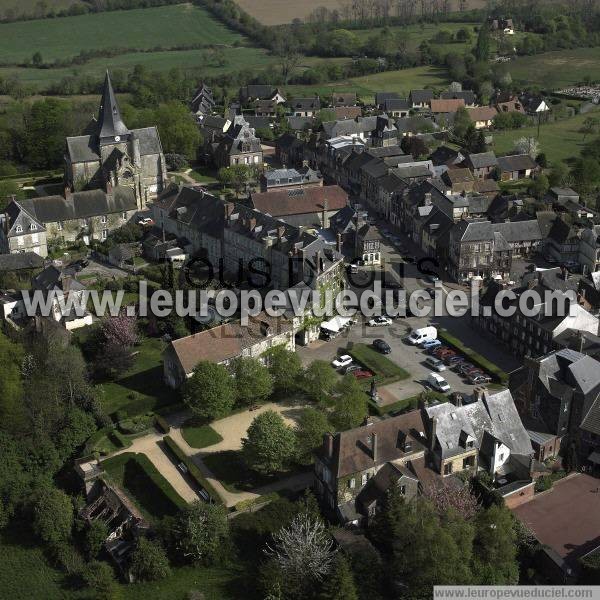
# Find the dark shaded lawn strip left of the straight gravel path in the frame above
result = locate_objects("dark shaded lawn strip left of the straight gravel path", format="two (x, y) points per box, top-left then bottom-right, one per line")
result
(102, 452), (187, 520)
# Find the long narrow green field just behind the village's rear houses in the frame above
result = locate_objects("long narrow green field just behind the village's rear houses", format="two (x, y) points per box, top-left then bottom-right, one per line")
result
(286, 67), (450, 102)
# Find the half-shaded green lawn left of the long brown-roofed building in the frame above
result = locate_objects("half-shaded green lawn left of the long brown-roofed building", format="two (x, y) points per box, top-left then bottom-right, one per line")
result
(101, 338), (179, 415)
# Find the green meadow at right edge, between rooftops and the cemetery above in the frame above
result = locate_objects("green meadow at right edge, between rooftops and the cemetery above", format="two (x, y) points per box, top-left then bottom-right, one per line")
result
(493, 109), (600, 162)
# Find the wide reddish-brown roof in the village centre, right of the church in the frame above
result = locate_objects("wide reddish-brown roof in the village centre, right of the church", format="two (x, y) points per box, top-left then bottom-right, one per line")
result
(250, 185), (348, 217)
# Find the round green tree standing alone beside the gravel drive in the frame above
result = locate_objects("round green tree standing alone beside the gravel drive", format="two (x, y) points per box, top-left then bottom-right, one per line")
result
(242, 410), (296, 474)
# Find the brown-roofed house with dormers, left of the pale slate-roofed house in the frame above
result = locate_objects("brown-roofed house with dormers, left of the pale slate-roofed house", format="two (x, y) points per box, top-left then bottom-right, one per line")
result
(314, 410), (427, 522)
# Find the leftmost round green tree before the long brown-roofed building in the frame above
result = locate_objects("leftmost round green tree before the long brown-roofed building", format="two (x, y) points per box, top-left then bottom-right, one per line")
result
(182, 361), (235, 420)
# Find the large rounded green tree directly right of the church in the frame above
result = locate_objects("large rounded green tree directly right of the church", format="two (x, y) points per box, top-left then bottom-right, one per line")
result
(154, 100), (201, 159)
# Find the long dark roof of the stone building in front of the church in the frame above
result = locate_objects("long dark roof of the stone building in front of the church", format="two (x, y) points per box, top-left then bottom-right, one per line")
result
(21, 186), (137, 223)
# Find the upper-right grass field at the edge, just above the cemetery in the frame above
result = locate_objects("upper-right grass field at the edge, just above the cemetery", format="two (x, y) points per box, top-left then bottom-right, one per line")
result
(508, 48), (600, 90)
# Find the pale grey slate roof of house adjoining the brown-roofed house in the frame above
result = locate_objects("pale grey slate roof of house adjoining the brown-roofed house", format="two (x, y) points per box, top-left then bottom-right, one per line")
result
(425, 390), (533, 458)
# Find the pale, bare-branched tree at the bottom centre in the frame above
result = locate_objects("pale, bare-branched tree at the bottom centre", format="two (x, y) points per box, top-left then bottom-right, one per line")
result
(265, 513), (336, 597)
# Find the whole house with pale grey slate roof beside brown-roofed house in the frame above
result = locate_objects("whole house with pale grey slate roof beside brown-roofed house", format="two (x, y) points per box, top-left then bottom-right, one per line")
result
(425, 388), (533, 489)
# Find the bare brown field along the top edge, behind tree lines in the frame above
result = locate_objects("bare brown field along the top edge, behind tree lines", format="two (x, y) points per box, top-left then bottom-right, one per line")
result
(236, 0), (486, 25)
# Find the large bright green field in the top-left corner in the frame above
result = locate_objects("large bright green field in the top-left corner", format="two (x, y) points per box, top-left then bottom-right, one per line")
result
(0, 4), (245, 63)
